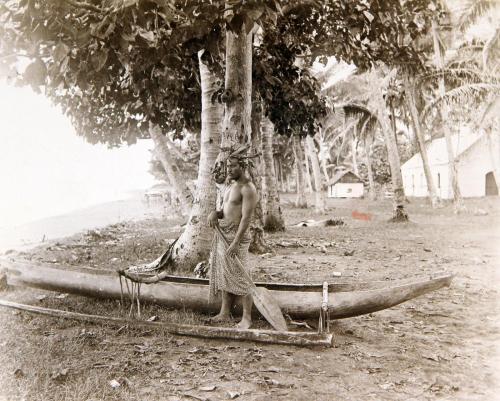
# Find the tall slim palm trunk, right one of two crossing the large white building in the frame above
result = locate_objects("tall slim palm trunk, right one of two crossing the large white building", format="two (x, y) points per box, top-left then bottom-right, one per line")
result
(432, 20), (464, 212)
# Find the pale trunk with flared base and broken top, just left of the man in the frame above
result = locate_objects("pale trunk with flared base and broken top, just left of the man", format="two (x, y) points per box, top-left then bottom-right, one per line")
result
(168, 52), (223, 271)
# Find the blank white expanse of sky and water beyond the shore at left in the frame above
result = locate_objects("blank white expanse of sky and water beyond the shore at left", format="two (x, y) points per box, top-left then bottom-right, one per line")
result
(0, 82), (155, 228)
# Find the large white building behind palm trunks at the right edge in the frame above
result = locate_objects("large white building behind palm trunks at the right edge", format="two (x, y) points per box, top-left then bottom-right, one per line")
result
(401, 134), (500, 199)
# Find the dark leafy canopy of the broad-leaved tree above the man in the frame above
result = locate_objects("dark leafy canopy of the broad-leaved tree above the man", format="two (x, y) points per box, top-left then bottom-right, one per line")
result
(0, 0), (446, 268)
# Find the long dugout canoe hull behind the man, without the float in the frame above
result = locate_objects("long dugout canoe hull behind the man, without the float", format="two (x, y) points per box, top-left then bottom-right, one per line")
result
(0, 259), (453, 319)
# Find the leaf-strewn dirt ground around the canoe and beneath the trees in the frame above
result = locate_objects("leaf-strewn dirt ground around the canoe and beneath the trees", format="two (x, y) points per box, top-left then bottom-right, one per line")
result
(0, 196), (500, 401)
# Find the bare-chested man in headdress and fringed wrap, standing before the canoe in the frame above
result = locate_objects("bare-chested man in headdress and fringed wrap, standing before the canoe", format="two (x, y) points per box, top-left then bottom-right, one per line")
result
(208, 155), (257, 329)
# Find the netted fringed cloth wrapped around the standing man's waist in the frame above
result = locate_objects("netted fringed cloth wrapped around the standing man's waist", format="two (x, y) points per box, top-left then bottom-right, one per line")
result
(209, 220), (252, 299)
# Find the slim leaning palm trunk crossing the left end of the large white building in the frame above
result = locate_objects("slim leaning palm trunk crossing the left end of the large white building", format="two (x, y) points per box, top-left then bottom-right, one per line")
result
(405, 77), (439, 208)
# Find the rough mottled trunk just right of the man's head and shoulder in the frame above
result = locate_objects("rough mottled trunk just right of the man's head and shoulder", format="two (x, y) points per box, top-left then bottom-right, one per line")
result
(261, 117), (285, 232)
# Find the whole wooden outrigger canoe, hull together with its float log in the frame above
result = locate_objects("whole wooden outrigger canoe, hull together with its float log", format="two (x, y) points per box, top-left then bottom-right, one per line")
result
(0, 259), (453, 345)
